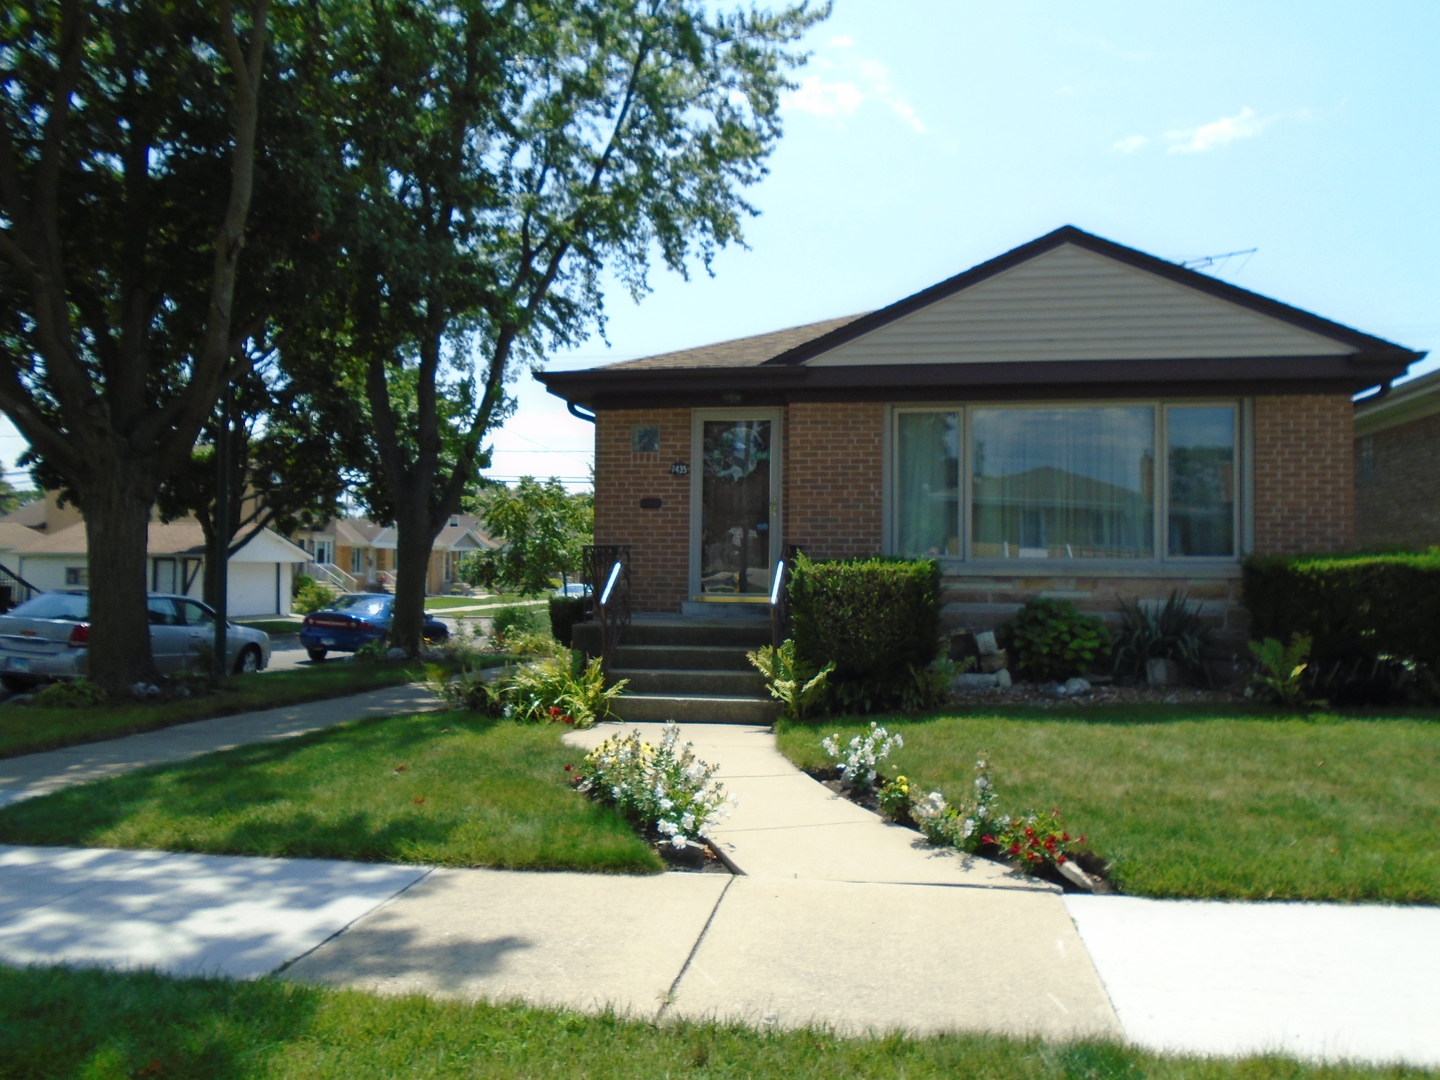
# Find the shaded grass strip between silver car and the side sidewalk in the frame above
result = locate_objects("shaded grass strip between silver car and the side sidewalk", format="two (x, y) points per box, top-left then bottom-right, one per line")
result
(0, 657), (455, 757)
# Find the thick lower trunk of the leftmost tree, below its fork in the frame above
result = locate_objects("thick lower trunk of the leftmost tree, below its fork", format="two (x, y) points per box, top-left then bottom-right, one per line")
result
(79, 466), (157, 691)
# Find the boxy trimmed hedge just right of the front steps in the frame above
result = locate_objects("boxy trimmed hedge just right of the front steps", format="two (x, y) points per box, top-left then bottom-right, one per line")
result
(789, 554), (940, 684)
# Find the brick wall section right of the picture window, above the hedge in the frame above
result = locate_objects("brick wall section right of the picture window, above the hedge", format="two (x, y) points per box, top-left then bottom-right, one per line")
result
(1254, 395), (1355, 554)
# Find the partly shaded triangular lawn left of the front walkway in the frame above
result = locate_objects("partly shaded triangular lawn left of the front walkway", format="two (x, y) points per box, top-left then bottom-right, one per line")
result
(0, 713), (664, 874)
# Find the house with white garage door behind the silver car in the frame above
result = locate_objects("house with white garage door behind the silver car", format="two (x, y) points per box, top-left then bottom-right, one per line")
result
(0, 507), (308, 618)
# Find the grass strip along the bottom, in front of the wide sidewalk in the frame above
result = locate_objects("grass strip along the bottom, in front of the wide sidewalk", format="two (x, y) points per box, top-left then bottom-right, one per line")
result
(0, 968), (1436, 1080)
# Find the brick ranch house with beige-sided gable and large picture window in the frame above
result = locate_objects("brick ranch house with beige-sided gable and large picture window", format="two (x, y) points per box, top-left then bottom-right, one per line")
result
(541, 226), (1423, 656)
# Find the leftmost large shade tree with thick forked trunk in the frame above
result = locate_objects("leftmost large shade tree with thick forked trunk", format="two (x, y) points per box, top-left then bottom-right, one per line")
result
(0, 0), (269, 685)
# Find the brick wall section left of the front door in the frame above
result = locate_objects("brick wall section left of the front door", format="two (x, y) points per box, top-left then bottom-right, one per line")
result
(595, 409), (698, 612)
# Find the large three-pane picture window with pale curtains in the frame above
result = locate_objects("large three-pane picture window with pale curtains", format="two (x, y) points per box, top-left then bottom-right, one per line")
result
(891, 402), (1240, 560)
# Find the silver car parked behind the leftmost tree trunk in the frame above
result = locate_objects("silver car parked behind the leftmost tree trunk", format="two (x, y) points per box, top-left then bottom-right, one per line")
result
(0, 590), (269, 691)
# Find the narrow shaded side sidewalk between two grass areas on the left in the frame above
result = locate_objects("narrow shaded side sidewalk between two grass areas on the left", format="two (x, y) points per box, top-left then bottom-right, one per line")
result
(0, 684), (438, 806)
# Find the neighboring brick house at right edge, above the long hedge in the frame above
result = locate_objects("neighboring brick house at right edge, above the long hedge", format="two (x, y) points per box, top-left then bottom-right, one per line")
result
(1355, 372), (1440, 547)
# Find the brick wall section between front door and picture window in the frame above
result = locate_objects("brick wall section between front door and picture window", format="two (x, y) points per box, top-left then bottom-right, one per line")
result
(785, 402), (886, 559)
